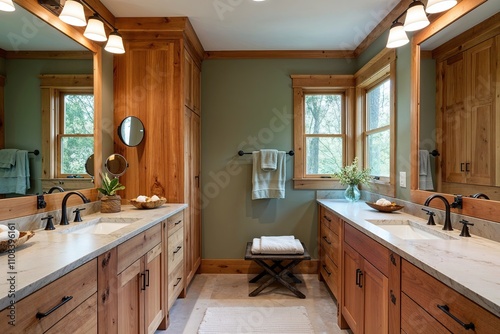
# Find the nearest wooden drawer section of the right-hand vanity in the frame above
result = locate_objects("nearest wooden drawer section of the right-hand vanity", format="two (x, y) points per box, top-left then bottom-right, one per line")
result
(401, 260), (500, 334)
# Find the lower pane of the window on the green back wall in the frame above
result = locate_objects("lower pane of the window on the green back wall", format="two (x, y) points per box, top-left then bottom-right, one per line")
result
(306, 137), (342, 175)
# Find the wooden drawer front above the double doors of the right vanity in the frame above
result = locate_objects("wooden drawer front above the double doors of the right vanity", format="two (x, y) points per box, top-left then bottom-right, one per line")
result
(344, 223), (389, 277)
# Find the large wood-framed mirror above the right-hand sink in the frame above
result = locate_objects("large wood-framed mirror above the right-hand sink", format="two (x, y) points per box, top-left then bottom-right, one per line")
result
(411, 0), (500, 222)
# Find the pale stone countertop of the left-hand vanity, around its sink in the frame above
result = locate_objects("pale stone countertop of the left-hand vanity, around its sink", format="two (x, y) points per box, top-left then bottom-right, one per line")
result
(0, 204), (187, 310)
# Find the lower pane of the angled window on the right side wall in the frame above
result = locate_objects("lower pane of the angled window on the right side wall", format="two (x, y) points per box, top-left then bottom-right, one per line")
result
(367, 130), (391, 177)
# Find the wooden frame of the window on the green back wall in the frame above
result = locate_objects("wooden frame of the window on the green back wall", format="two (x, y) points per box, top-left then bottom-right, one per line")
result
(291, 75), (355, 189)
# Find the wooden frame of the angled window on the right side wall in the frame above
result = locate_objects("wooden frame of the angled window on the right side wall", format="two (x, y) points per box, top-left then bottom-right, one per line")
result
(355, 49), (396, 197)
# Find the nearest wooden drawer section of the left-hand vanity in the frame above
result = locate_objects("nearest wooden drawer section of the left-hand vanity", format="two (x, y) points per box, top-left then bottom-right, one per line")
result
(0, 259), (97, 334)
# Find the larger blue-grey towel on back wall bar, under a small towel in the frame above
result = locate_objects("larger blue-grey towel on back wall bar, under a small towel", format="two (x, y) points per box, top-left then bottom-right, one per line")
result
(252, 151), (286, 199)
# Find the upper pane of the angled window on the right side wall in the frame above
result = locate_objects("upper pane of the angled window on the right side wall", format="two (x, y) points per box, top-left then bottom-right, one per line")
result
(366, 79), (391, 130)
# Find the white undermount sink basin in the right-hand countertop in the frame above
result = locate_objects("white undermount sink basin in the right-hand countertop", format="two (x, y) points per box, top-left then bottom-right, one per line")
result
(367, 219), (456, 240)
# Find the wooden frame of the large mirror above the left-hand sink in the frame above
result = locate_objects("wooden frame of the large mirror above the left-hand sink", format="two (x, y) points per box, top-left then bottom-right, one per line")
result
(0, 0), (108, 220)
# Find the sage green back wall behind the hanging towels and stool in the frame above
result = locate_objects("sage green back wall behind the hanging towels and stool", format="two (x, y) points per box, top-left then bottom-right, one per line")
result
(201, 59), (356, 259)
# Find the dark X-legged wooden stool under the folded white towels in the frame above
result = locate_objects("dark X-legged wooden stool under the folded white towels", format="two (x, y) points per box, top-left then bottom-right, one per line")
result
(245, 242), (311, 298)
